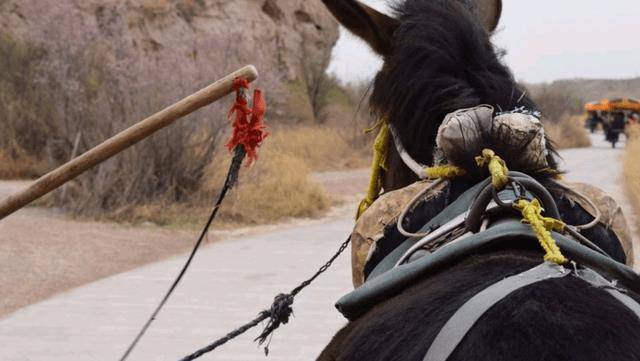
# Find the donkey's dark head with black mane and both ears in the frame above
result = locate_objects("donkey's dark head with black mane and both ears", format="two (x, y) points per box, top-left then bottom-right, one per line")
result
(322, 0), (552, 190)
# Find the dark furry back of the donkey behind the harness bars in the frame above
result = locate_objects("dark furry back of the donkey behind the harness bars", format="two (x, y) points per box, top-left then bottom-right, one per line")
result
(318, 250), (640, 361)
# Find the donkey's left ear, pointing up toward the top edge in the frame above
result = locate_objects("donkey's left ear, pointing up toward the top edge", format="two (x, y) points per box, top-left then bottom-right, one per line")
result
(322, 0), (398, 55)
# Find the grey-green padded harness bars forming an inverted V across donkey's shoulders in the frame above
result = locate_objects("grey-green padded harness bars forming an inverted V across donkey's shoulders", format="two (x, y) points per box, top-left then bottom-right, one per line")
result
(336, 172), (640, 312)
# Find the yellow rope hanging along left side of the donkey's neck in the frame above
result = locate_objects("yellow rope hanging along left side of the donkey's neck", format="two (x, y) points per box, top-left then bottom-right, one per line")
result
(356, 120), (389, 220)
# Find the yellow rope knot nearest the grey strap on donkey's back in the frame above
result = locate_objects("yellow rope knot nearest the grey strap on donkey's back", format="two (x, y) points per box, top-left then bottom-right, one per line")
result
(514, 199), (568, 264)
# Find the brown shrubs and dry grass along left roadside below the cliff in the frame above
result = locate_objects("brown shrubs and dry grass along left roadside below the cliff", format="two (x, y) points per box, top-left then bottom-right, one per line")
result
(0, 32), (369, 225)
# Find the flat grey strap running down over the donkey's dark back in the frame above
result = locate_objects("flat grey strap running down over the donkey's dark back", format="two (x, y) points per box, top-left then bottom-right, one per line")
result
(424, 262), (571, 361)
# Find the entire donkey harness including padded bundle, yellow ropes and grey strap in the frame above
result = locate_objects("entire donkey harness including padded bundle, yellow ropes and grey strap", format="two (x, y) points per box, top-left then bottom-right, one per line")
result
(336, 106), (640, 361)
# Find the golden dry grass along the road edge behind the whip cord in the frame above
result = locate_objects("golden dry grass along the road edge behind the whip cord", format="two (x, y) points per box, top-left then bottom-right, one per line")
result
(100, 125), (369, 228)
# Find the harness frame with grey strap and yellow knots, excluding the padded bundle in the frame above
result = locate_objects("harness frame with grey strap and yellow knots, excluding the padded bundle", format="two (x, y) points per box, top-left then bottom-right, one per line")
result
(336, 141), (640, 361)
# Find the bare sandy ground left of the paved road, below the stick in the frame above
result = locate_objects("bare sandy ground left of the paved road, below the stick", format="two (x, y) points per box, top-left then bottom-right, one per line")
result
(0, 191), (194, 317)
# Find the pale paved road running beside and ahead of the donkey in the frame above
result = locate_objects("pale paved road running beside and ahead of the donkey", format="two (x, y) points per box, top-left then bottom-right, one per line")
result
(0, 136), (629, 361)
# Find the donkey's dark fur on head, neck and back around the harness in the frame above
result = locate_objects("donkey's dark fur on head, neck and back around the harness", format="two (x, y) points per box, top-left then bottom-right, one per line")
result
(319, 0), (640, 361)
